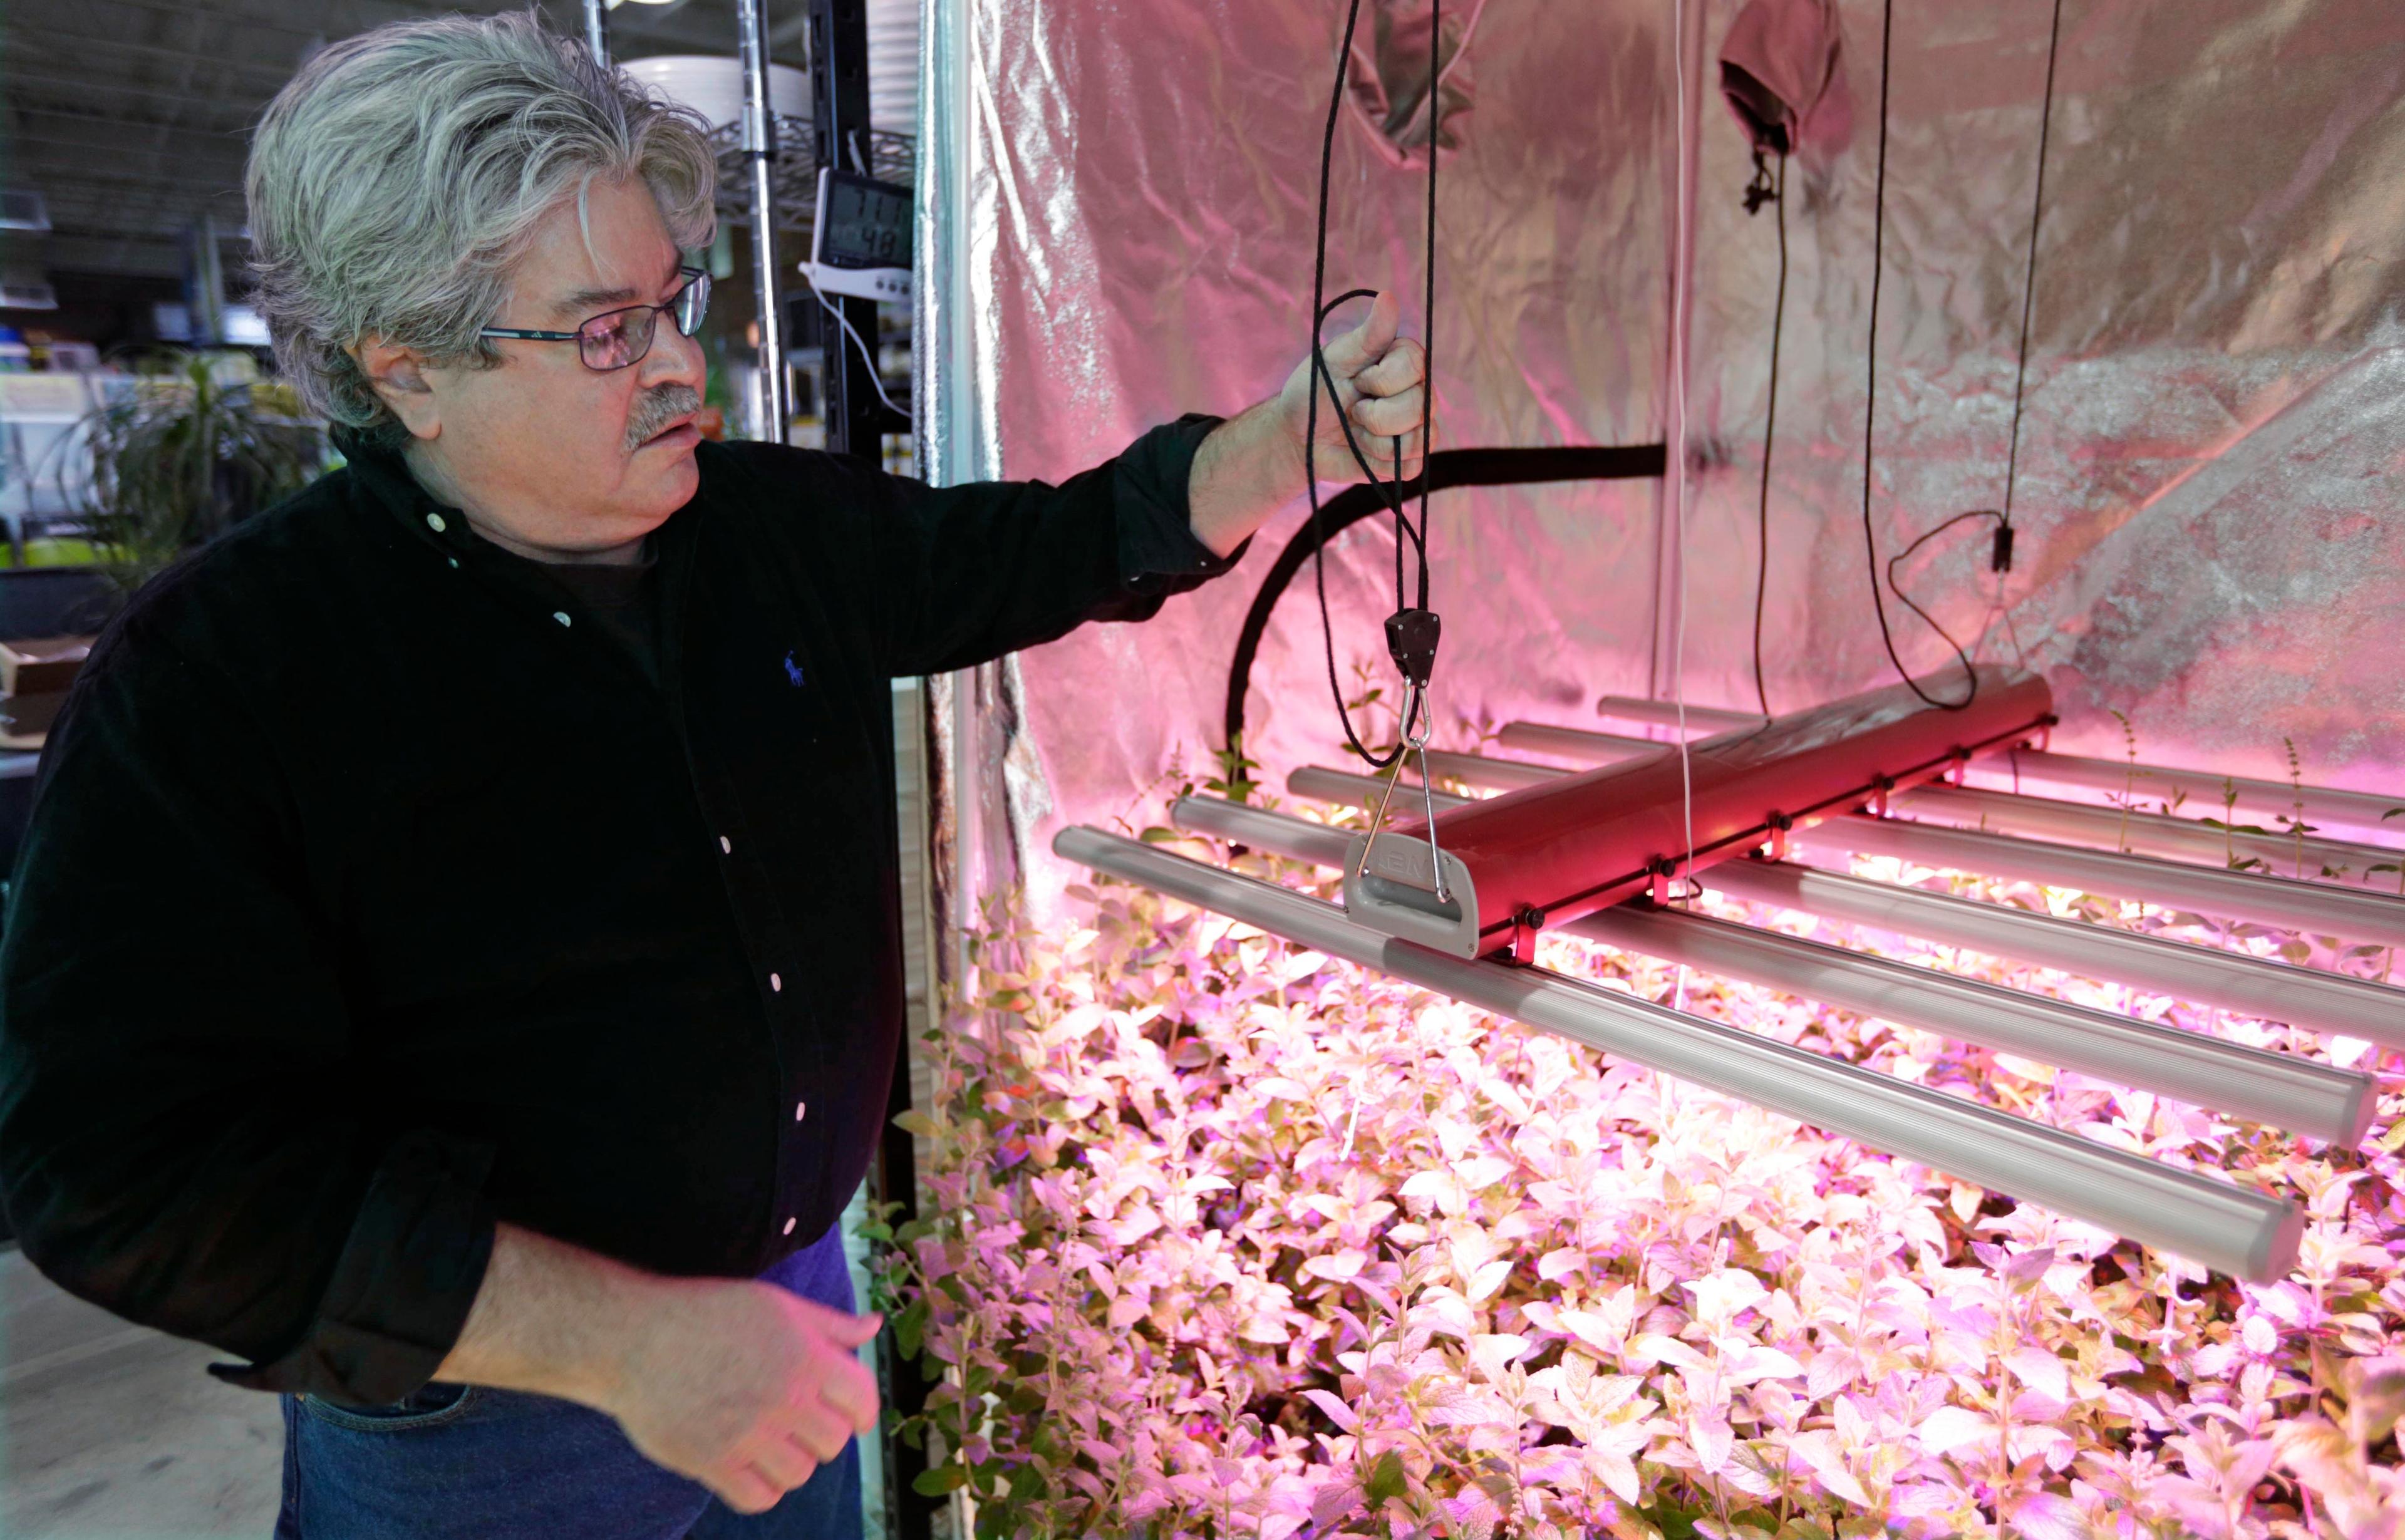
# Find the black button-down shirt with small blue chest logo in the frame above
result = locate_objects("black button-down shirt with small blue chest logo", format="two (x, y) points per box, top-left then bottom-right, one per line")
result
(0, 416), (1229, 1405)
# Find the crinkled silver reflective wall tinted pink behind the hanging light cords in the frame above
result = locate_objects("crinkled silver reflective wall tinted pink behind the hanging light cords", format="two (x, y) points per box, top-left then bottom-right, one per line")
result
(921, 0), (2405, 904)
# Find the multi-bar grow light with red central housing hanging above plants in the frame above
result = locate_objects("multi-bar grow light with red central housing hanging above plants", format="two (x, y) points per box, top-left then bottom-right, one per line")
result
(1053, 669), (2405, 1283)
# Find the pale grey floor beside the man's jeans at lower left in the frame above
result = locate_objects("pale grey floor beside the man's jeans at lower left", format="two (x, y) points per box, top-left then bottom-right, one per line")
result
(0, 1249), (284, 1540)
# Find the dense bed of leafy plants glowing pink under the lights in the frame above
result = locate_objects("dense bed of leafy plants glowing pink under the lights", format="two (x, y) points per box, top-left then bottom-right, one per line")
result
(890, 852), (2405, 1540)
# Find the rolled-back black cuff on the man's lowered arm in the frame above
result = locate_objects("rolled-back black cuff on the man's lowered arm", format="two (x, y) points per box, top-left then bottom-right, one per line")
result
(209, 1129), (495, 1408)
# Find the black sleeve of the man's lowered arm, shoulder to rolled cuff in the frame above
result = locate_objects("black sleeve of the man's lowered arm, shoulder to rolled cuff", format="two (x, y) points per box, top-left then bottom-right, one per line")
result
(0, 606), (495, 1405)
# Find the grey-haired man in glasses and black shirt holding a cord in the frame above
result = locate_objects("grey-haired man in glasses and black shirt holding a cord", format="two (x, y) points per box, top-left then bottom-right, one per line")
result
(0, 17), (1421, 1540)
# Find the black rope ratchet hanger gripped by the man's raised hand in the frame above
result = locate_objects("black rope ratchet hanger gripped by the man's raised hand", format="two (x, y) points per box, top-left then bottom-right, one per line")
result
(1303, 0), (1443, 902)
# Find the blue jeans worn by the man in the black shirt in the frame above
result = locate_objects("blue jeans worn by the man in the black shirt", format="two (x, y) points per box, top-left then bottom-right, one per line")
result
(274, 1227), (861, 1540)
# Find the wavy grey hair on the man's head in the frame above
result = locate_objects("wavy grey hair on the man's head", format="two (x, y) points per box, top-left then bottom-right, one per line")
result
(243, 12), (716, 445)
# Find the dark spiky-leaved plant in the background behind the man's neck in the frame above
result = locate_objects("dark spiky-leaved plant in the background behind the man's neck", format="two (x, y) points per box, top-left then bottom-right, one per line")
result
(77, 354), (324, 594)
